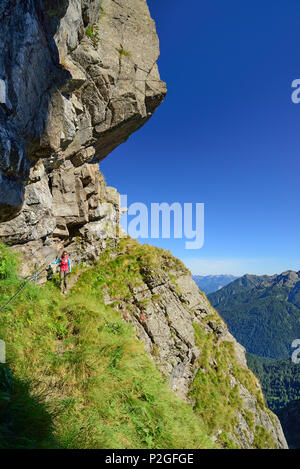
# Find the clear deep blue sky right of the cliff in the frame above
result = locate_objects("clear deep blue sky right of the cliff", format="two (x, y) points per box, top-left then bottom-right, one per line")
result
(100, 0), (300, 275)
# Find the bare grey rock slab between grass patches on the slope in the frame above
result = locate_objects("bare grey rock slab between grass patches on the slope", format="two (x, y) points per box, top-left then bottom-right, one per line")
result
(108, 268), (247, 398)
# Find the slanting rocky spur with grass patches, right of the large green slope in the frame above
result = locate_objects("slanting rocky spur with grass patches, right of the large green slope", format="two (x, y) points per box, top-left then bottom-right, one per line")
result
(103, 239), (287, 448)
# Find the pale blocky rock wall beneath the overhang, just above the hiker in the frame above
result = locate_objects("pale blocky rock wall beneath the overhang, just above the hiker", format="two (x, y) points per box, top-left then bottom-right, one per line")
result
(0, 161), (121, 281)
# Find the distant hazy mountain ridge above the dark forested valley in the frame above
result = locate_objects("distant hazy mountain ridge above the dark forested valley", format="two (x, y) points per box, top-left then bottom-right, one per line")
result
(208, 271), (300, 359)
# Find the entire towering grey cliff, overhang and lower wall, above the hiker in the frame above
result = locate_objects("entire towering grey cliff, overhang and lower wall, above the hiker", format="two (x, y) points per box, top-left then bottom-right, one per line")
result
(0, 0), (166, 267)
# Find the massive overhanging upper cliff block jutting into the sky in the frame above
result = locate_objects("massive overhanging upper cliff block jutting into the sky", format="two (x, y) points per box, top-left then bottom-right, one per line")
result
(0, 0), (166, 218)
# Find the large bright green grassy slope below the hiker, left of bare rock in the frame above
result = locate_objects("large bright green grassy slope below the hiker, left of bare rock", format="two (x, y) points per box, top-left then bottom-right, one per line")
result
(0, 246), (214, 448)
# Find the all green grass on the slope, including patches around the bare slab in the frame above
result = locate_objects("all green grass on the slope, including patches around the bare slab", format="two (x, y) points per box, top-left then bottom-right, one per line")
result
(0, 240), (282, 449)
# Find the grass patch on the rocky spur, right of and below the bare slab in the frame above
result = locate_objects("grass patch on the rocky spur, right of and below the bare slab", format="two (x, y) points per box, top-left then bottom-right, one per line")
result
(190, 316), (276, 449)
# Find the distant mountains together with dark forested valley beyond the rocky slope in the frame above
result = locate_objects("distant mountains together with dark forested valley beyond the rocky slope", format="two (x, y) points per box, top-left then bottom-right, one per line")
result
(208, 271), (300, 448)
